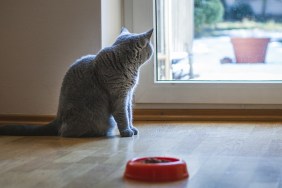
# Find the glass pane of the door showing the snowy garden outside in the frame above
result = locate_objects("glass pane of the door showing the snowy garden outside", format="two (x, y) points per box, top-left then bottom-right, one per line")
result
(155, 0), (282, 81)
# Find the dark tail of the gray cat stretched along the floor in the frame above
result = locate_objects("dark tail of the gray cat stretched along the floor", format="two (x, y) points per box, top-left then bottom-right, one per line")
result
(0, 119), (60, 136)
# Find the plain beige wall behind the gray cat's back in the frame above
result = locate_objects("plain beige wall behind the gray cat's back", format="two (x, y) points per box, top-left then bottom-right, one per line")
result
(0, 0), (101, 115)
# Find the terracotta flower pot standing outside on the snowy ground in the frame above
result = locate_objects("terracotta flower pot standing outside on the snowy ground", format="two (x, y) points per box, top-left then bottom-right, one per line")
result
(231, 37), (270, 63)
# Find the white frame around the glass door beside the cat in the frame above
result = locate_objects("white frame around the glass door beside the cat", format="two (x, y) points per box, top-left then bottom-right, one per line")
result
(124, 0), (282, 108)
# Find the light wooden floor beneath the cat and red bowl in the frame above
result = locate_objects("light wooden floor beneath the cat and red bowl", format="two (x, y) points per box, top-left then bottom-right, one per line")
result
(0, 122), (282, 188)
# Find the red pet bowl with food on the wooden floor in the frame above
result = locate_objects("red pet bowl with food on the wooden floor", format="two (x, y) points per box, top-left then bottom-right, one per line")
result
(124, 157), (189, 182)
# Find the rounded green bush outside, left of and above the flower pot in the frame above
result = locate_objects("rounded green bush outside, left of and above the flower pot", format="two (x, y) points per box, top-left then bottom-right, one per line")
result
(194, 0), (224, 33)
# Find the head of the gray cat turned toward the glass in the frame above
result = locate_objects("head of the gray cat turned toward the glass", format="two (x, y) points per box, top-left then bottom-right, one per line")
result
(113, 27), (153, 65)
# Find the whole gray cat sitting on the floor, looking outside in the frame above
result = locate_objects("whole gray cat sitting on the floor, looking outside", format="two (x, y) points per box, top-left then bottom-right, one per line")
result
(0, 28), (153, 137)
